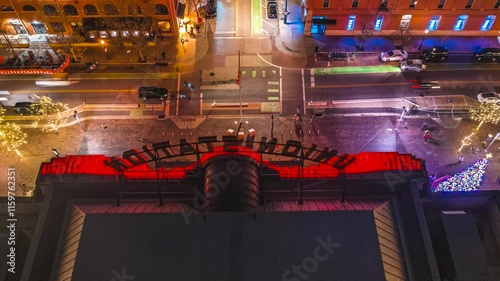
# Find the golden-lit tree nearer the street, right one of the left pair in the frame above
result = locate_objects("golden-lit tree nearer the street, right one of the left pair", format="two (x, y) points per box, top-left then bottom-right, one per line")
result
(30, 96), (70, 132)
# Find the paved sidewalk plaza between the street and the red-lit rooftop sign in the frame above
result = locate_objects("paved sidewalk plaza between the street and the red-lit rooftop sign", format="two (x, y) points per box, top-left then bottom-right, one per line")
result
(0, 112), (500, 196)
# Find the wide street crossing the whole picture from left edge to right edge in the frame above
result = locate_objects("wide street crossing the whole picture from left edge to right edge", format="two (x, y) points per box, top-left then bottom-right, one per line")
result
(0, 65), (500, 115)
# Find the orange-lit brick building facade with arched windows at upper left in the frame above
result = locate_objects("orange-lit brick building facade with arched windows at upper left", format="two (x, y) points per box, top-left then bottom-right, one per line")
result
(0, 0), (179, 39)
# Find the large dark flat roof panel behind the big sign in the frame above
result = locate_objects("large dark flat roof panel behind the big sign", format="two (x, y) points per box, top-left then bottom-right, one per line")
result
(72, 211), (385, 281)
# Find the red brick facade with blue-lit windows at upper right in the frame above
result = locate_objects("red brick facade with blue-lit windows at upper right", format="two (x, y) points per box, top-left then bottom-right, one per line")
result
(304, 0), (500, 36)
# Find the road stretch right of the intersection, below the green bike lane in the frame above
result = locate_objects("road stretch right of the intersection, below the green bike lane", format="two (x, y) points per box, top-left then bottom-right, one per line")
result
(307, 69), (500, 100)
